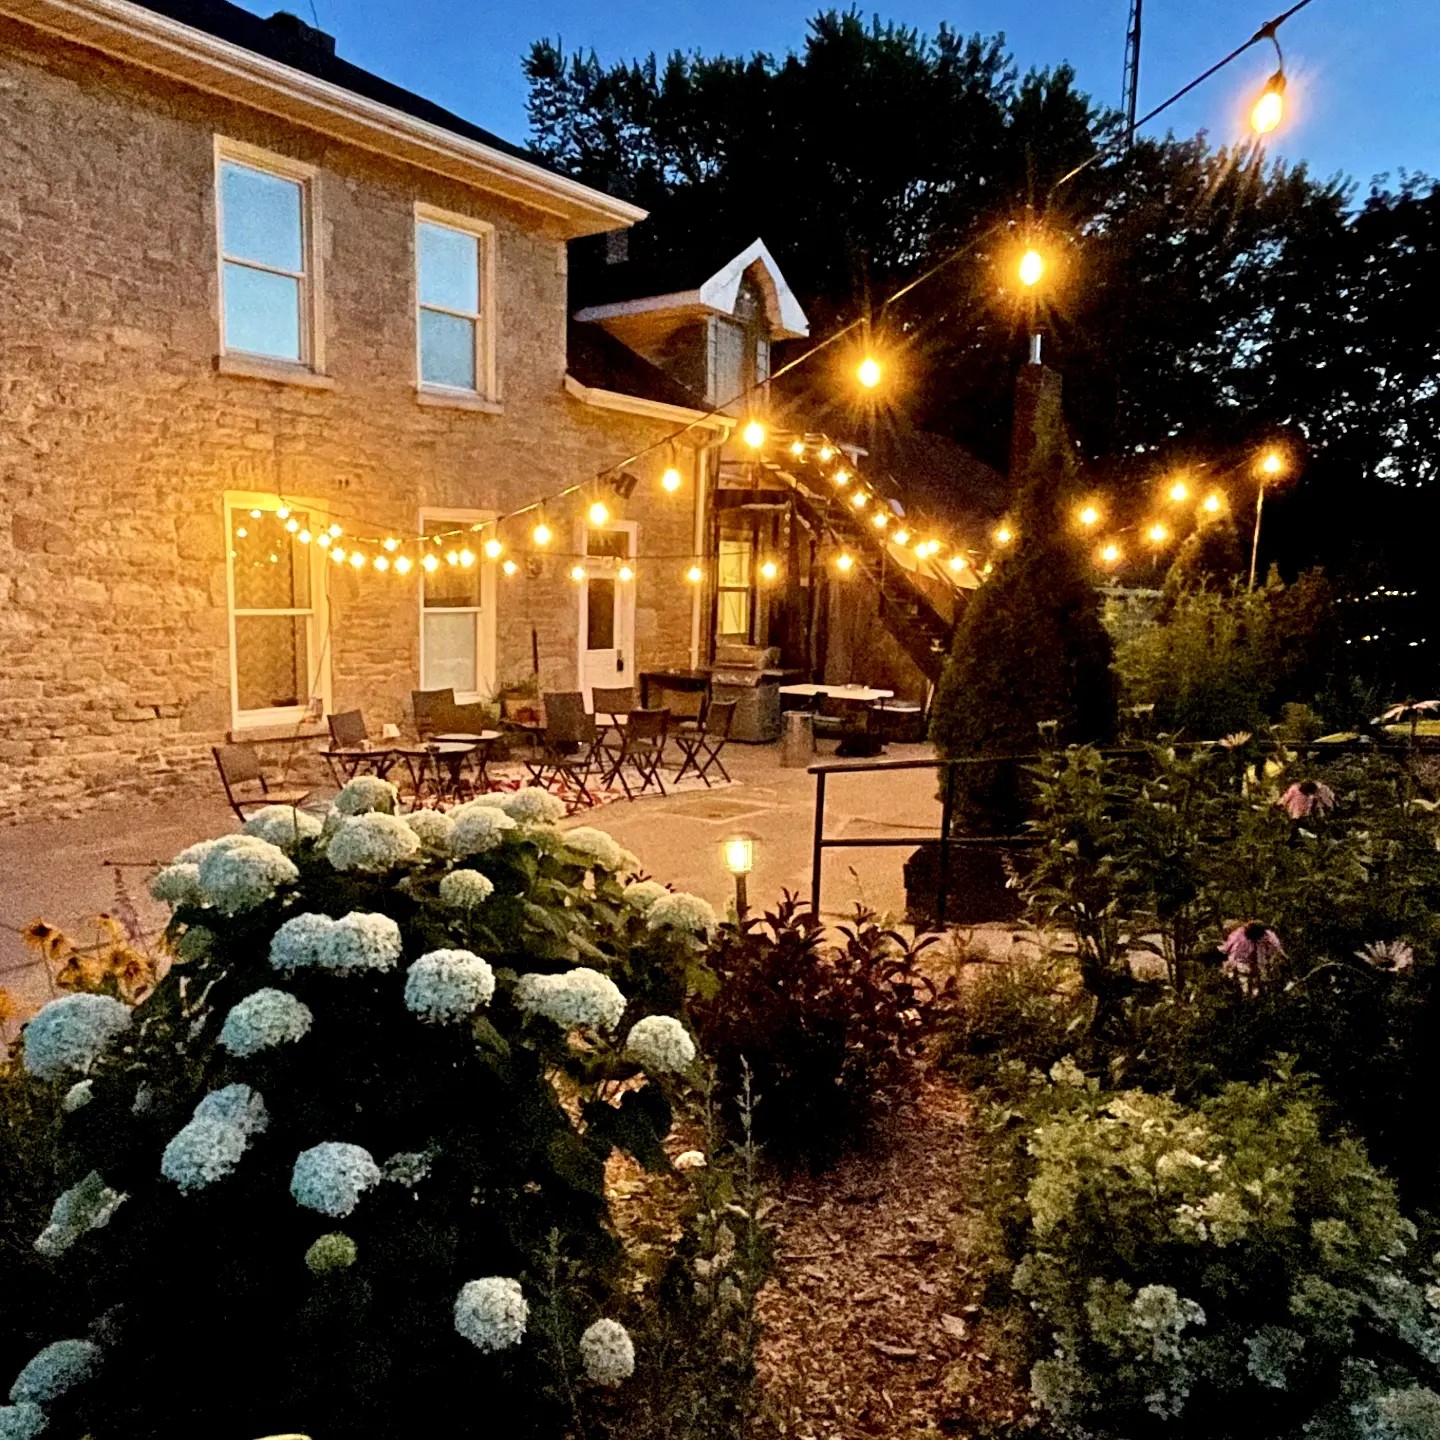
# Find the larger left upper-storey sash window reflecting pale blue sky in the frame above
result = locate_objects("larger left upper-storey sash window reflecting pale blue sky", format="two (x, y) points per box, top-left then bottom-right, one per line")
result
(216, 141), (315, 364)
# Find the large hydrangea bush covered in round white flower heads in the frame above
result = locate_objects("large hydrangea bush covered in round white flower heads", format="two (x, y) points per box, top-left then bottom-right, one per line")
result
(0, 800), (713, 1440)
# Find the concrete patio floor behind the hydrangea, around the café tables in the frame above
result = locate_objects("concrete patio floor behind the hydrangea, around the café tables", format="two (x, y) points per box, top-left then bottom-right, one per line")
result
(0, 744), (939, 1030)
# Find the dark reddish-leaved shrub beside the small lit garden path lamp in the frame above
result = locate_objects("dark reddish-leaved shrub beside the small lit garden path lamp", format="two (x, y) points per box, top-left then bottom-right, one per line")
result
(694, 894), (933, 1165)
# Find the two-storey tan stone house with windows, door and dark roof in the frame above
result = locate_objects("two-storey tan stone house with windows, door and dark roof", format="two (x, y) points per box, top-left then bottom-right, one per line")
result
(0, 0), (804, 815)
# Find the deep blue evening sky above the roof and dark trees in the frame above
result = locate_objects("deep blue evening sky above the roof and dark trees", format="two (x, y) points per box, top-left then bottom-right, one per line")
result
(286, 0), (1440, 184)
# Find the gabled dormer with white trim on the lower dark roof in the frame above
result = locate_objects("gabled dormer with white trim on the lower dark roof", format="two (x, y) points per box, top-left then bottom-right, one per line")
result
(575, 240), (809, 410)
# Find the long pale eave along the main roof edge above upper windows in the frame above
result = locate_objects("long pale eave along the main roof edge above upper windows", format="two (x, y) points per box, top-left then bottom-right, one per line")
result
(0, 0), (647, 239)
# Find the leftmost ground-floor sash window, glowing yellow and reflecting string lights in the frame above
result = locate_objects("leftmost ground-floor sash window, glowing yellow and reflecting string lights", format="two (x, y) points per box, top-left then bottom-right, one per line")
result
(228, 503), (324, 726)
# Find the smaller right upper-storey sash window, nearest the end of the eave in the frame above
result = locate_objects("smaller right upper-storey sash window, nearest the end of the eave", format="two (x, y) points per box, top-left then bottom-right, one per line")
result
(415, 206), (494, 399)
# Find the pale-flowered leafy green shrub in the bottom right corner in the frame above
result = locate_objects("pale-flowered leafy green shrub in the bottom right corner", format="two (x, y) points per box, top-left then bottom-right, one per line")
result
(1014, 1067), (1440, 1440)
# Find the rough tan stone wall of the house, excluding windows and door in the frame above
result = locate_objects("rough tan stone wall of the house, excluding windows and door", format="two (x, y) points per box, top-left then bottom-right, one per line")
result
(0, 19), (694, 816)
